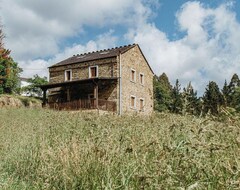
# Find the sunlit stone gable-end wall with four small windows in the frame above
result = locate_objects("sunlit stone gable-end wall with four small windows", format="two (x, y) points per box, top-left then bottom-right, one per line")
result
(121, 46), (153, 114)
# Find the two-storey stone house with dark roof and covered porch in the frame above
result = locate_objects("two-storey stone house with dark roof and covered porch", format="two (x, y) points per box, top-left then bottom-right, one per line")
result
(41, 44), (154, 115)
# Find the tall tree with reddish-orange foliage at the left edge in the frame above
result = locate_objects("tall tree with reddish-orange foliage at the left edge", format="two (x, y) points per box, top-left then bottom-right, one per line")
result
(0, 23), (22, 94)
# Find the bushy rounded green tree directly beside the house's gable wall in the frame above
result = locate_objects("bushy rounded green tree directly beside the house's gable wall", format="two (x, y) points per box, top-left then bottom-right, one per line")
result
(153, 73), (172, 111)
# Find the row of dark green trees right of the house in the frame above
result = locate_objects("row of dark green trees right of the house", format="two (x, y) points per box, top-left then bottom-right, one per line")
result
(153, 73), (240, 116)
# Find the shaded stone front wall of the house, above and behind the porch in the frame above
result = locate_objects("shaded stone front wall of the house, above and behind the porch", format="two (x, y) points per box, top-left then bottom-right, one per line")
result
(49, 58), (118, 102)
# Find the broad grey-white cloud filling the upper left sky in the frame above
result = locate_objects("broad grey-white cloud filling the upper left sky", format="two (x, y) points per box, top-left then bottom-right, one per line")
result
(1, 0), (156, 60)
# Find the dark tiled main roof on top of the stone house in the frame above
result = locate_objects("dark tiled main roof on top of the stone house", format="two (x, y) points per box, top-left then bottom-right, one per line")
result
(49, 44), (136, 68)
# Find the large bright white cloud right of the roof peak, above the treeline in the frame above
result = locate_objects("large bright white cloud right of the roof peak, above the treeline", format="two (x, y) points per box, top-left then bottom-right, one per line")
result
(125, 2), (240, 93)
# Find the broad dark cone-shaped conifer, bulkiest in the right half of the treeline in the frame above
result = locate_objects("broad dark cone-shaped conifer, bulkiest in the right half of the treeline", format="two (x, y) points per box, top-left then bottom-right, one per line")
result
(203, 81), (223, 115)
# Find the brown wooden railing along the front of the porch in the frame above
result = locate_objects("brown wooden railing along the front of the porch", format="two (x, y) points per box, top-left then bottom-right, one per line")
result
(48, 99), (117, 112)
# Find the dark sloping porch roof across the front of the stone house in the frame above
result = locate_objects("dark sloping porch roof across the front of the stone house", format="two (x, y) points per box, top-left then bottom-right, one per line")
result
(38, 77), (118, 90)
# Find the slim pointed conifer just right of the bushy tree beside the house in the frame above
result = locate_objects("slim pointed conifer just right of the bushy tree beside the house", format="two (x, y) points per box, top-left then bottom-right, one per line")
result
(171, 79), (183, 113)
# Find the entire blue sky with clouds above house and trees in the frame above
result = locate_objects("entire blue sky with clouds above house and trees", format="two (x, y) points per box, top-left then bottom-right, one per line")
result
(0, 0), (240, 95)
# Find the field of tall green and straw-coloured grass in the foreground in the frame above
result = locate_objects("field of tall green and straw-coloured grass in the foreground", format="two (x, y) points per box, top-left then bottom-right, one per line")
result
(0, 108), (240, 190)
